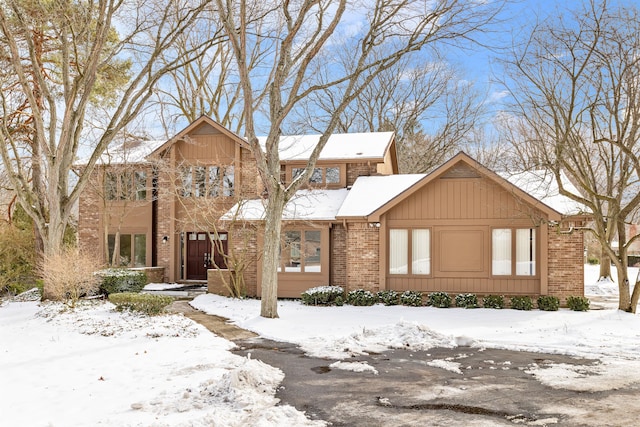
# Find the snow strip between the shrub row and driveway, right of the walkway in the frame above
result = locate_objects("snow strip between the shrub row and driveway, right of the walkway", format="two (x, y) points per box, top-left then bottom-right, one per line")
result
(192, 266), (640, 390)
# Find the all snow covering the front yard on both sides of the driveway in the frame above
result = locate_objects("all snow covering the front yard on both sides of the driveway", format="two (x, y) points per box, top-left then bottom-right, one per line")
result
(0, 266), (640, 426)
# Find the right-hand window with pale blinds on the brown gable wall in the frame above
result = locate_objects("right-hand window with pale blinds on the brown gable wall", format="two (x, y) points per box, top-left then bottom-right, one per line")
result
(491, 228), (536, 276)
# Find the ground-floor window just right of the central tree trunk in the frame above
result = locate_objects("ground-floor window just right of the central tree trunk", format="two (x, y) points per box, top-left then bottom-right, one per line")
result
(278, 230), (322, 273)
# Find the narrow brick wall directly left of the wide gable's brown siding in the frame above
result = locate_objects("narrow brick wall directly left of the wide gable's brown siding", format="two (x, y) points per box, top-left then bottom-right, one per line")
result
(346, 222), (380, 292)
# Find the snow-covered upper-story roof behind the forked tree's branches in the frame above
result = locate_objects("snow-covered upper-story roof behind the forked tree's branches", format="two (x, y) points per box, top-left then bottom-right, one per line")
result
(258, 132), (393, 161)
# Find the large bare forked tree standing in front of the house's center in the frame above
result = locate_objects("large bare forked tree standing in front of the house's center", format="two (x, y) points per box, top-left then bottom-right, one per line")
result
(216, 0), (504, 318)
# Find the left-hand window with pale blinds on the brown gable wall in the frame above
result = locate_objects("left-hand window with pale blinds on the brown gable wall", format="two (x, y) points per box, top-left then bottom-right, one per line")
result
(389, 228), (431, 275)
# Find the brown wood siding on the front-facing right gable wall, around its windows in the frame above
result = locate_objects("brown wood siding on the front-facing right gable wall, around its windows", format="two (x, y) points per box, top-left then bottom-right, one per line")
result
(381, 174), (548, 295)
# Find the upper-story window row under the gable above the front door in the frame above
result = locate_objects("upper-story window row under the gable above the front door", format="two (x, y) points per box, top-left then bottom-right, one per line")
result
(181, 166), (235, 197)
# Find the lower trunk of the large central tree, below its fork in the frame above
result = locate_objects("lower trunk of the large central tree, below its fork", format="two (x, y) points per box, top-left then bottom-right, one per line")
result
(260, 186), (286, 319)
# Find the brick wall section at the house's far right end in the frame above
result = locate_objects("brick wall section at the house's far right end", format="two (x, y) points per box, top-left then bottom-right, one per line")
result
(548, 226), (584, 304)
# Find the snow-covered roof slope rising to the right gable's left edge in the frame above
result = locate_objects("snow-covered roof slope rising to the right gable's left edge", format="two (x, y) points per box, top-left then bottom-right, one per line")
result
(337, 174), (426, 217)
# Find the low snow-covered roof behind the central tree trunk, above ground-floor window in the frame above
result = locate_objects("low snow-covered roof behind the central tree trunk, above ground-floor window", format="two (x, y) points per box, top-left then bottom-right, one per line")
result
(221, 188), (349, 221)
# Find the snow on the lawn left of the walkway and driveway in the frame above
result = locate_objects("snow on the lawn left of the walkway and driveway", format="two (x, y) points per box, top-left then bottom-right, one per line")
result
(0, 302), (324, 426)
